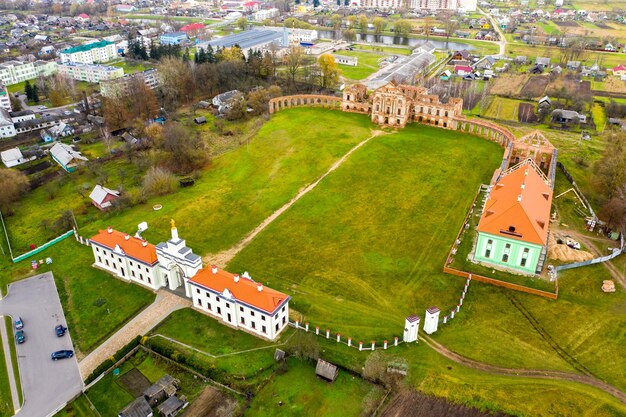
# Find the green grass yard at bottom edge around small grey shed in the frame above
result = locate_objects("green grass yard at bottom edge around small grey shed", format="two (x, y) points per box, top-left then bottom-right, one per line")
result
(245, 359), (384, 417)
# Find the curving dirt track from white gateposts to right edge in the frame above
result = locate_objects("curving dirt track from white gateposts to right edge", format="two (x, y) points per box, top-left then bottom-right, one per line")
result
(420, 335), (626, 404)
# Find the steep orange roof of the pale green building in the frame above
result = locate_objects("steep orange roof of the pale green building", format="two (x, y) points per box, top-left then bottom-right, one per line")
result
(478, 160), (552, 246)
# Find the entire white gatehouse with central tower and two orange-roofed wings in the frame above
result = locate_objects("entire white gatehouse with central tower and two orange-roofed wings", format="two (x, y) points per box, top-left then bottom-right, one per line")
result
(90, 221), (291, 340)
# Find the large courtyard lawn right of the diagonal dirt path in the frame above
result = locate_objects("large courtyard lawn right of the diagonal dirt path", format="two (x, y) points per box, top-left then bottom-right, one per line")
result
(229, 125), (502, 342)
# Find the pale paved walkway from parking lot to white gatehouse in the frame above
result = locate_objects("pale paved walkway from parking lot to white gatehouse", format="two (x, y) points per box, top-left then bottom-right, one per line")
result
(79, 289), (191, 378)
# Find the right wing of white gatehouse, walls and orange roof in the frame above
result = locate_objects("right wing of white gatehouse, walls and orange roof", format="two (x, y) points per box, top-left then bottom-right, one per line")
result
(189, 266), (290, 340)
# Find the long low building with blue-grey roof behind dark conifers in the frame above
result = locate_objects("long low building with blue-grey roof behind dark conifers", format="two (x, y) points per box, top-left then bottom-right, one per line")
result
(197, 29), (289, 56)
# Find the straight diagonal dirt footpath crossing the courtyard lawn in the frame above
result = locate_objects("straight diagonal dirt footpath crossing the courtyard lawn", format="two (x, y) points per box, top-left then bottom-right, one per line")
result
(202, 130), (387, 268)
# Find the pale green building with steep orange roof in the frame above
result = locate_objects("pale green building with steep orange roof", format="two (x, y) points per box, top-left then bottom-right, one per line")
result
(474, 159), (552, 275)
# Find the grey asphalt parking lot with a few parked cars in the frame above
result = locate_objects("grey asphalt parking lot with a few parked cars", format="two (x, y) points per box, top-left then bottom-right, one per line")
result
(0, 272), (83, 417)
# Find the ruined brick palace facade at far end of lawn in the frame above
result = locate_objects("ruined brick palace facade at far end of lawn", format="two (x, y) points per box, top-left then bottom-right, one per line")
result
(341, 83), (463, 129)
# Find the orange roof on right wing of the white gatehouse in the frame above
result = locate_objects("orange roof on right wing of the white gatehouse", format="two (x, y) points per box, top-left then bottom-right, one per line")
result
(189, 267), (289, 314)
